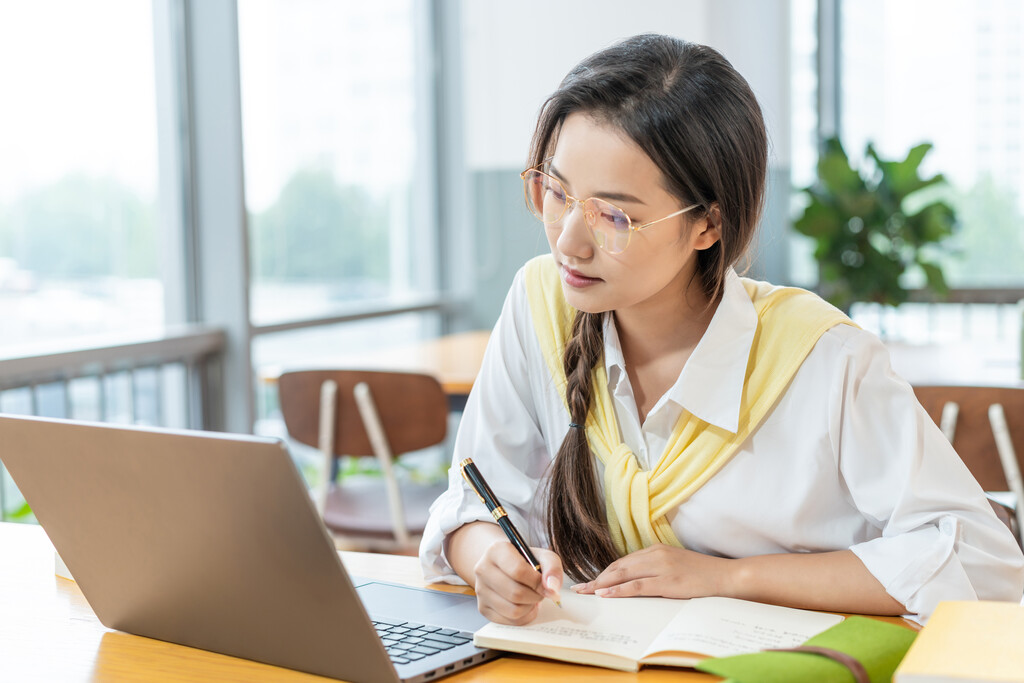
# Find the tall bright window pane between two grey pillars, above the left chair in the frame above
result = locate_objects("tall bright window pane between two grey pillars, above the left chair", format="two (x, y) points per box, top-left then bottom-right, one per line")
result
(239, 0), (434, 323)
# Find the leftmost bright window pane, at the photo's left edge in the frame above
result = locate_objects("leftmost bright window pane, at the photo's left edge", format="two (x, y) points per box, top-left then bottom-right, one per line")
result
(0, 0), (163, 348)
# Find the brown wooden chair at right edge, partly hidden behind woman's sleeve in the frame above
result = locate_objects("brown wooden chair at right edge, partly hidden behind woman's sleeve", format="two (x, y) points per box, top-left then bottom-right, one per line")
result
(913, 386), (1024, 543)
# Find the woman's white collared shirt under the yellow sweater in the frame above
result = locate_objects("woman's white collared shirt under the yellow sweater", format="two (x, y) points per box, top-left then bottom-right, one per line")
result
(420, 270), (1024, 618)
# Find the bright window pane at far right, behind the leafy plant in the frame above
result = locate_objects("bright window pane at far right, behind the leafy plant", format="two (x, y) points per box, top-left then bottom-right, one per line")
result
(842, 0), (1024, 287)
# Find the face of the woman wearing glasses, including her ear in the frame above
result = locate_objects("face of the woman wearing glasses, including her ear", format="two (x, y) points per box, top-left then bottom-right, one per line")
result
(546, 113), (719, 313)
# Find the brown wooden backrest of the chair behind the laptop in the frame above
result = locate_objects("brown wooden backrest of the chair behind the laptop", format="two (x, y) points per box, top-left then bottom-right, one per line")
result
(278, 370), (449, 457)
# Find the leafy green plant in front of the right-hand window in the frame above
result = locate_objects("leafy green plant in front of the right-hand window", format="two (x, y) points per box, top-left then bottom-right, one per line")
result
(794, 137), (956, 311)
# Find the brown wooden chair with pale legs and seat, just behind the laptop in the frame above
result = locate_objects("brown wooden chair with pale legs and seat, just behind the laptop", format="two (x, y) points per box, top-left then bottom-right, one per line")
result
(278, 370), (449, 551)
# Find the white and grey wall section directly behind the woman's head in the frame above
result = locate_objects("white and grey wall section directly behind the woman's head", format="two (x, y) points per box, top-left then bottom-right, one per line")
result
(445, 0), (791, 327)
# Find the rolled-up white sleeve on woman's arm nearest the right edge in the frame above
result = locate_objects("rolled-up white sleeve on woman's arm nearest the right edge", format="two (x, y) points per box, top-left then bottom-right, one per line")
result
(829, 335), (1024, 621)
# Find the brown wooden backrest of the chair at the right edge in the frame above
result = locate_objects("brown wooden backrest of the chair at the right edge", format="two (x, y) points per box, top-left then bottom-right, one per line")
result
(913, 386), (1024, 490)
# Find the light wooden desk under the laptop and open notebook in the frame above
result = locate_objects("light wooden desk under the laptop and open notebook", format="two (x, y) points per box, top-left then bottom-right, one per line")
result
(0, 522), (737, 683)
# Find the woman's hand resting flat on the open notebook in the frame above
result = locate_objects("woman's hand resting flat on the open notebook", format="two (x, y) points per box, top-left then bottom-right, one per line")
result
(572, 544), (735, 598)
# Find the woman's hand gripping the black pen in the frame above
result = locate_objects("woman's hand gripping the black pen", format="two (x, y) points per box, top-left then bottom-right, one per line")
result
(473, 541), (562, 626)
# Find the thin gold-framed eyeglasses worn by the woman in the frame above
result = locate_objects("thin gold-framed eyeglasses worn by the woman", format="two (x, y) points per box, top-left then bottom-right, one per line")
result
(519, 168), (700, 254)
